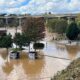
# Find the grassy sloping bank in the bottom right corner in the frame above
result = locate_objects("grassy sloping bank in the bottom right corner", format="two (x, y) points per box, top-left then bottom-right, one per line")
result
(52, 58), (80, 80)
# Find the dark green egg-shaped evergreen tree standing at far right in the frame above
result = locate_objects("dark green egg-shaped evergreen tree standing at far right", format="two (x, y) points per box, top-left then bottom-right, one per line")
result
(66, 22), (79, 40)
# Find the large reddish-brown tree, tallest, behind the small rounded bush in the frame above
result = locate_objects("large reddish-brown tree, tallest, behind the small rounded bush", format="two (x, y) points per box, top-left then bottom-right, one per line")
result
(22, 17), (45, 51)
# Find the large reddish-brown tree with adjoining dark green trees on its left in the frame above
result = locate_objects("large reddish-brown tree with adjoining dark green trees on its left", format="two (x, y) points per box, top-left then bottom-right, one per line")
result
(0, 17), (45, 53)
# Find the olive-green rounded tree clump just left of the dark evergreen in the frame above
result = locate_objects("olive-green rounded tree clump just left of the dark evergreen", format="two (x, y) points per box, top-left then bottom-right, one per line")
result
(47, 19), (68, 34)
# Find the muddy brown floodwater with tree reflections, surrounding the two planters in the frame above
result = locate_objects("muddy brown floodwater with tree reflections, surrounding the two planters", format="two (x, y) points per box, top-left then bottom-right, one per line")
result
(0, 42), (80, 80)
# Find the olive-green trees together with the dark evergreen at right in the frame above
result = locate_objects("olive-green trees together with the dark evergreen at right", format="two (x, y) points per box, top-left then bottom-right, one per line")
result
(47, 19), (80, 40)
